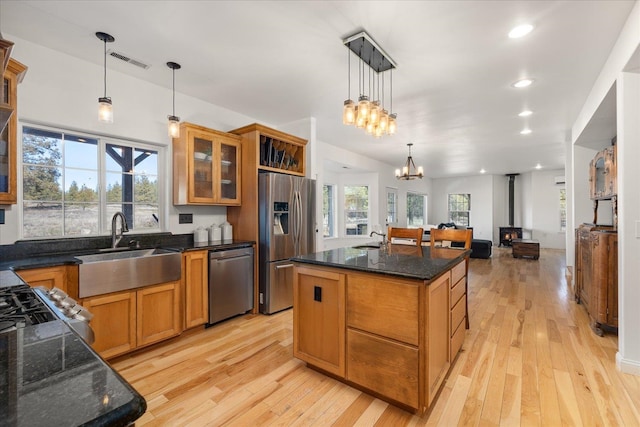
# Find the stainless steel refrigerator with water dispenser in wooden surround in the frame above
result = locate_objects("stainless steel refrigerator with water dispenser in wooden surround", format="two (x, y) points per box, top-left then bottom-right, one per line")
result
(258, 173), (316, 314)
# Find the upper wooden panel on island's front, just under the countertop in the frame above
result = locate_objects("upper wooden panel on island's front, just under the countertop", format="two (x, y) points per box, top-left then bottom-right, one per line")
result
(347, 274), (421, 345)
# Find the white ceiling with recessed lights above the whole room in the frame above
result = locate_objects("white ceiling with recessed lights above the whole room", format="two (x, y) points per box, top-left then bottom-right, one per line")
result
(0, 0), (634, 177)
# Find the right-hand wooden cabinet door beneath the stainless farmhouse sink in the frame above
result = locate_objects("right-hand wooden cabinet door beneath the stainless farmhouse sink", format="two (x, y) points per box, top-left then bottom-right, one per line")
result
(136, 281), (182, 347)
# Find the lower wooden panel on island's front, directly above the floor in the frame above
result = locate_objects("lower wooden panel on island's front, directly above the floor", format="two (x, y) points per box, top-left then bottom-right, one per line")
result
(347, 328), (419, 408)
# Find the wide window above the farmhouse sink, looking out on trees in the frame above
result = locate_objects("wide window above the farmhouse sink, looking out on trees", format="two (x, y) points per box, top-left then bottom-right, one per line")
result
(22, 126), (160, 238)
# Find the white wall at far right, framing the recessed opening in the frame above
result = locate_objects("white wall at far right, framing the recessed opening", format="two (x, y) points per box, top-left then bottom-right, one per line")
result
(571, 2), (640, 375)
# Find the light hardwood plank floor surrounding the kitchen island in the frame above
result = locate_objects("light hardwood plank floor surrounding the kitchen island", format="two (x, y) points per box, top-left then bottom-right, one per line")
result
(112, 248), (640, 426)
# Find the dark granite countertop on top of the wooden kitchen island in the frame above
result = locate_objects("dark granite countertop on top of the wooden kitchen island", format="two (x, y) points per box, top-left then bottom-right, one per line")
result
(291, 245), (471, 280)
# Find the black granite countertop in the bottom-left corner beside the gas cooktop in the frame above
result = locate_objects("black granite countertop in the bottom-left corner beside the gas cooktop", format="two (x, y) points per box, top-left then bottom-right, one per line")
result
(0, 320), (147, 427)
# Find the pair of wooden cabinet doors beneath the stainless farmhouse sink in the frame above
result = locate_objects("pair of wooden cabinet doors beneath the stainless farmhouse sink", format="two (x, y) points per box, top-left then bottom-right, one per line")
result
(81, 281), (182, 359)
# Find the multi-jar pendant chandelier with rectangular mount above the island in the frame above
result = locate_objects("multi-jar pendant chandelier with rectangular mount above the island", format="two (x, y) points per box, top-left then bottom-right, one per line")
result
(342, 31), (398, 138)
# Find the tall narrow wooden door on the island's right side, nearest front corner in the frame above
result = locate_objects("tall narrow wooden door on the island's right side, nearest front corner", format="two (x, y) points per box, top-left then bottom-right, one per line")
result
(425, 272), (451, 406)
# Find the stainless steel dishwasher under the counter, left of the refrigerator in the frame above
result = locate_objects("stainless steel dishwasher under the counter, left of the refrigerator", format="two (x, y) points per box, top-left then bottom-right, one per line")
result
(209, 248), (254, 324)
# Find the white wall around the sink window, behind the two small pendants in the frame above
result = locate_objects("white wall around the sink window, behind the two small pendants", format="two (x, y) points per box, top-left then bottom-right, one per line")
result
(0, 34), (256, 244)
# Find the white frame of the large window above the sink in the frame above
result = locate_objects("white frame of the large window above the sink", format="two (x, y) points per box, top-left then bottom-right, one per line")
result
(17, 120), (168, 240)
